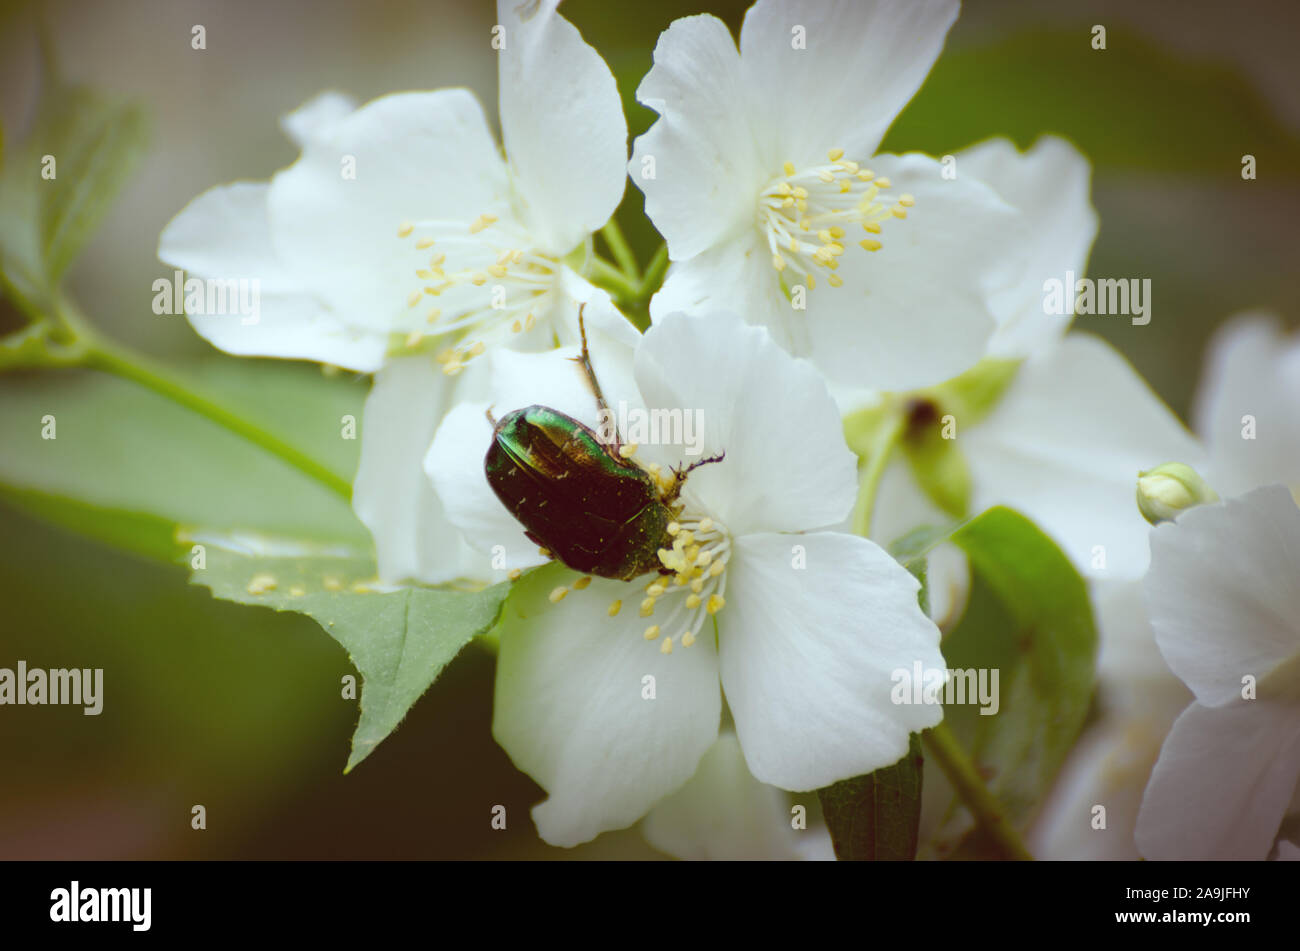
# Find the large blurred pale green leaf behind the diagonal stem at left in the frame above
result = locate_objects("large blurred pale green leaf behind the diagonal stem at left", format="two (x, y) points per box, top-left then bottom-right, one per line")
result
(0, 357), (371, 560)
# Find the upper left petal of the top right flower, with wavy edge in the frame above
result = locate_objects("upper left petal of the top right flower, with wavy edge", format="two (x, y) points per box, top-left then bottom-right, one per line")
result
(628, 14), (759, 259)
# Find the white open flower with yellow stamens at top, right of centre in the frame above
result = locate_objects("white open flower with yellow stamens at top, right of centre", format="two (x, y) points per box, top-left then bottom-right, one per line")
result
(629, 0), (1028, 390)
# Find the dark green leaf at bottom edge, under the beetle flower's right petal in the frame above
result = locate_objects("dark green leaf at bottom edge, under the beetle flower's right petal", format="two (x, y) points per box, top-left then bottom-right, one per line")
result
(818, 734), (924, 861)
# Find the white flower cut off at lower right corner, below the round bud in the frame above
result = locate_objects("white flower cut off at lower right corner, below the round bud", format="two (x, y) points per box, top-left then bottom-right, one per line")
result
(1138, 486), (1300, 859)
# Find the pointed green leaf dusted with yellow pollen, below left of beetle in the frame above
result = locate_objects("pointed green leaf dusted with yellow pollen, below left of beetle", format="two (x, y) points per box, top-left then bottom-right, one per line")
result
(183, 531), (510, 772)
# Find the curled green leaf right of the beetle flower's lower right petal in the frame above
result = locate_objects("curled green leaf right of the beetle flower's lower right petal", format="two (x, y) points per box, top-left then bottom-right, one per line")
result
(935, 508), (1097, 857)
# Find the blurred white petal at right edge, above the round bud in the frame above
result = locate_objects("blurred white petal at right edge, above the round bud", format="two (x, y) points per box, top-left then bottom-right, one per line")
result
(1193, 313), (1300, 496)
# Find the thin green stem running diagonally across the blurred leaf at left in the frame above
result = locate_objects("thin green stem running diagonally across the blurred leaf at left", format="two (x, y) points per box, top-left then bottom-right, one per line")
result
(83, 338), (352, 501)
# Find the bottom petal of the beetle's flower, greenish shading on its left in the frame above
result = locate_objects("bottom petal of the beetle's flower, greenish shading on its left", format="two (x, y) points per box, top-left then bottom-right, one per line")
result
(493, 569), (722, 846)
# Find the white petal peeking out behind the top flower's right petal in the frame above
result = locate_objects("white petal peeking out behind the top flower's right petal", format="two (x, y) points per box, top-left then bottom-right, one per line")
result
(954, 135), (1097, 356)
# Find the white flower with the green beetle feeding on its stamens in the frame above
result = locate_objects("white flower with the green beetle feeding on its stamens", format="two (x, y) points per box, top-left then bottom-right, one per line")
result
(426, 316), (944, 844)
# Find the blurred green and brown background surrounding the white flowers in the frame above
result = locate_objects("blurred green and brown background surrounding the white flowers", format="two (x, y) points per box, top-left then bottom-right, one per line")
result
(0, 0), (1300, 859)
